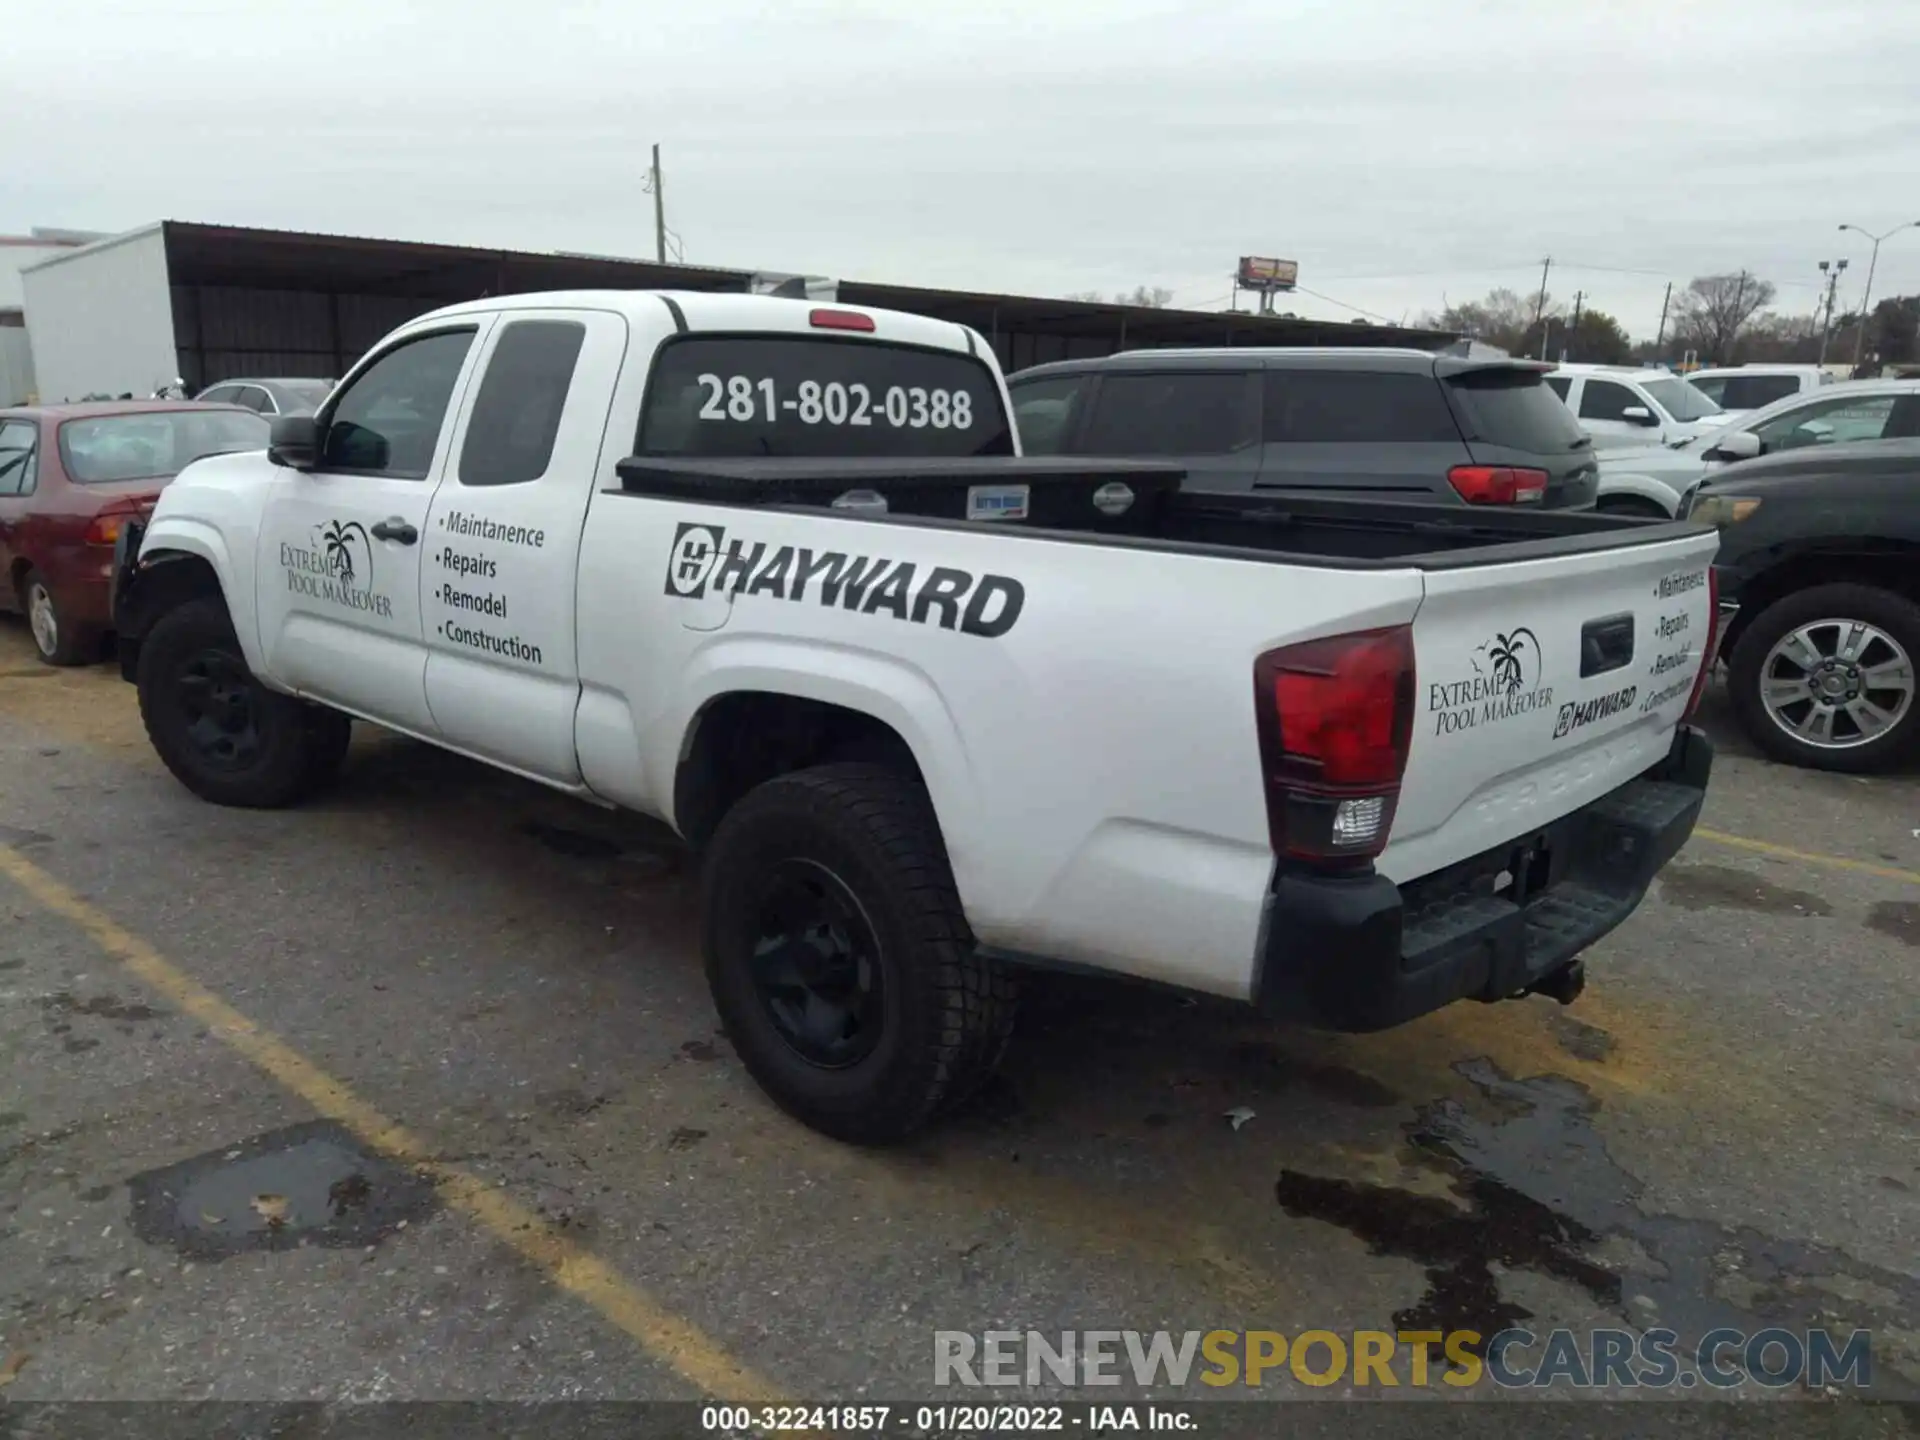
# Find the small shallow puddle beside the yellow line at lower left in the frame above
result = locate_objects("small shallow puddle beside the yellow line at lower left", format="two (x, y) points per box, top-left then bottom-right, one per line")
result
(127, 1119), (438, 1260)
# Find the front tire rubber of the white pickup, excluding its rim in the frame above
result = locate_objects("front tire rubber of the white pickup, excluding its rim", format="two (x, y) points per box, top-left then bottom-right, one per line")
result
(136, 599), (346, 810)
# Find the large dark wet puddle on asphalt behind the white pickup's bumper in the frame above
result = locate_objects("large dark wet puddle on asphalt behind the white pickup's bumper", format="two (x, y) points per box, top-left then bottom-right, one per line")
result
(1275, 1058), (1920, 1384)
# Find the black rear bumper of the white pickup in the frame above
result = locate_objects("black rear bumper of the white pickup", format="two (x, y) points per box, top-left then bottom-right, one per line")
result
(1254, 726), (1713, 1031)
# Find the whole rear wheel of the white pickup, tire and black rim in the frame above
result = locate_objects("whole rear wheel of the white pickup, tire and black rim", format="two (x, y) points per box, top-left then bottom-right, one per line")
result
(701, 762), (1016, 1144)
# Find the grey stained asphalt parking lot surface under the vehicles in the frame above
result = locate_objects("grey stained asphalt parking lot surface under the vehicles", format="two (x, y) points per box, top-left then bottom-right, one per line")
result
(0, 620), (1920, 1434)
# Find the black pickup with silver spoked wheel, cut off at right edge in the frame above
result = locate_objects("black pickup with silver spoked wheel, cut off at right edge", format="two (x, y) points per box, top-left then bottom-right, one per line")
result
(1688, 440), (1920, 774)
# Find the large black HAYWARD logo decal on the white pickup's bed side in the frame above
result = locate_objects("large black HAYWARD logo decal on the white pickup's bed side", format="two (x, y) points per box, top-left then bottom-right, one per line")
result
(666, 520), (1027, 639)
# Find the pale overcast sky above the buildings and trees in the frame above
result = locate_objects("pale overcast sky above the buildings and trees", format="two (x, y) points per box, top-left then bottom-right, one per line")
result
(0, 0), (1920, 336)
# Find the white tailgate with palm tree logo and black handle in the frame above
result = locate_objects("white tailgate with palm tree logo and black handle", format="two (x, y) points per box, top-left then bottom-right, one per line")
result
(1379, 534), (1718, 883)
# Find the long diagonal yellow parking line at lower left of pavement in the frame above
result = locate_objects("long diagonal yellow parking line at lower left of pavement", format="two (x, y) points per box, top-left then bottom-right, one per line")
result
(0, 847), (783, 1404)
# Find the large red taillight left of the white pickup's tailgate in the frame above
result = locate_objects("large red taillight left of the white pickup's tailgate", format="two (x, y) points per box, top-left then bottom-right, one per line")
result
(1254, 626), (1413, 860)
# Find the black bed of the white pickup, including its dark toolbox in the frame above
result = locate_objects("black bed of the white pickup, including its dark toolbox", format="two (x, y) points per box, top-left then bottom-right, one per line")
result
(614, 455), (1701, 570)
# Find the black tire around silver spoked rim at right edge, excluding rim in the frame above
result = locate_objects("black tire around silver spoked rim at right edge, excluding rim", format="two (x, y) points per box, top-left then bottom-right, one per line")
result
(1728, 584), (1920, 776)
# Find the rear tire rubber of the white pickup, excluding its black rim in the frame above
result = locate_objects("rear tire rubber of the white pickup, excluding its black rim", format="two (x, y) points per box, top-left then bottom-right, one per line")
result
(701, 762), (1018, 1144)
